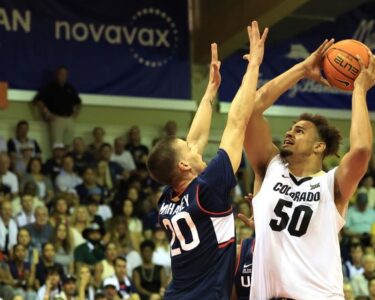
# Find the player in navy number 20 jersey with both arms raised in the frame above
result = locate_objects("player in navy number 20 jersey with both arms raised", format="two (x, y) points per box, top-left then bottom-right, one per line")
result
(147, 22), (268, 300)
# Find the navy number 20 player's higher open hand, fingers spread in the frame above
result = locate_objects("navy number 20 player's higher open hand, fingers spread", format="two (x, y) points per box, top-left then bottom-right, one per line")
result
(243, 21), (268, 65)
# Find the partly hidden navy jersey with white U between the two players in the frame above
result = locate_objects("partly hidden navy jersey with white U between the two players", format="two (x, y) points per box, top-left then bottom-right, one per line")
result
(234, 239), (254, 300)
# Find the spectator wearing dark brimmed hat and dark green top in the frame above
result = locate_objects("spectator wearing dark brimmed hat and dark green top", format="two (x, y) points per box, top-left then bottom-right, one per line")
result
(74, 222), (104, 269)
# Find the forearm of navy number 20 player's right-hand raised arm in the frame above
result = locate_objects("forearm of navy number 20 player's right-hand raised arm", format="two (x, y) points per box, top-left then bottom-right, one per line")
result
(228, 62), (259, 128)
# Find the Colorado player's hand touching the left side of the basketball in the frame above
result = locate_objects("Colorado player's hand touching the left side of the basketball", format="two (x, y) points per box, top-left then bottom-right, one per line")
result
(301, 39), (335, 86)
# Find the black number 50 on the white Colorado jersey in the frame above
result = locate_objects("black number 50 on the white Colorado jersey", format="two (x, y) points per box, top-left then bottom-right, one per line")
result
(270, 199), (313, 237)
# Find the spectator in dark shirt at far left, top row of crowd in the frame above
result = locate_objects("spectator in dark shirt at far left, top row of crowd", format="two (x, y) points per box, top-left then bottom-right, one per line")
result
(7, 120), (42, 162)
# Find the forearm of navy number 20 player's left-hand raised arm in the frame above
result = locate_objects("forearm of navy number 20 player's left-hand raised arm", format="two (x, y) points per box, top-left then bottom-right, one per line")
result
(186, 88), (216, 153)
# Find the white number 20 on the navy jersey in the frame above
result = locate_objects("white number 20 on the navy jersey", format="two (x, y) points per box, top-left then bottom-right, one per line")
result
(163, 211), (200, 256)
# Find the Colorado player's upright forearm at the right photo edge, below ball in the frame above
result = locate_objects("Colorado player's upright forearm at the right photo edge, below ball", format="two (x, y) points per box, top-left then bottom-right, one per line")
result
(350, 86), (372, 154)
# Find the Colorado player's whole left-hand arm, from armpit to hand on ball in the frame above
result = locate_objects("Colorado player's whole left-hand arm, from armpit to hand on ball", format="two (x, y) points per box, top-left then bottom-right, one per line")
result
(245, 39), (334, 175)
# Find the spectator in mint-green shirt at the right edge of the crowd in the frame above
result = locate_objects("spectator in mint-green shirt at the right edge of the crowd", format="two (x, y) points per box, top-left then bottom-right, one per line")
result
(345, 193), (375, 240)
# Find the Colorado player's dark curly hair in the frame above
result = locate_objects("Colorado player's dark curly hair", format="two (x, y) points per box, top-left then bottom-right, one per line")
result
(298, 113), (342, 157)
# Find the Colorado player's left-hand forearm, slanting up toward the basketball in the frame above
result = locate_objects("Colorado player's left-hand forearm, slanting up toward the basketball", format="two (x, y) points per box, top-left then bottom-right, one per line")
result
(254, 63), (304, 114)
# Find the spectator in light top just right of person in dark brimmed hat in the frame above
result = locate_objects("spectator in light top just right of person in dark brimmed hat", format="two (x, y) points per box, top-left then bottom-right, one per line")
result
(95, 243), (118, 287)
